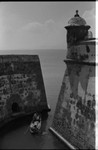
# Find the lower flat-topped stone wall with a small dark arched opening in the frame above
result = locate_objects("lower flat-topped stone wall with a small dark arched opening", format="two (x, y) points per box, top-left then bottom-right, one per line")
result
(0, 55), (48, 123)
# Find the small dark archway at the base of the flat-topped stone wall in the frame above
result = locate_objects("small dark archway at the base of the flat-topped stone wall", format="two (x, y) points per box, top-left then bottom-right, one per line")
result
(6, 94), (24, 115)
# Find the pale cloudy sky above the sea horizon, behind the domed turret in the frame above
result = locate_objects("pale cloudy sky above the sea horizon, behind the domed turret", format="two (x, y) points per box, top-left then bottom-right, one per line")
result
(0, 2), (95, 50)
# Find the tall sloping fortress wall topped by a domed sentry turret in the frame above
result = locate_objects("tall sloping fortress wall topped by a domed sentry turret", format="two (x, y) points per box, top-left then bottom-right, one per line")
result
(50, 12), (96, 149)
